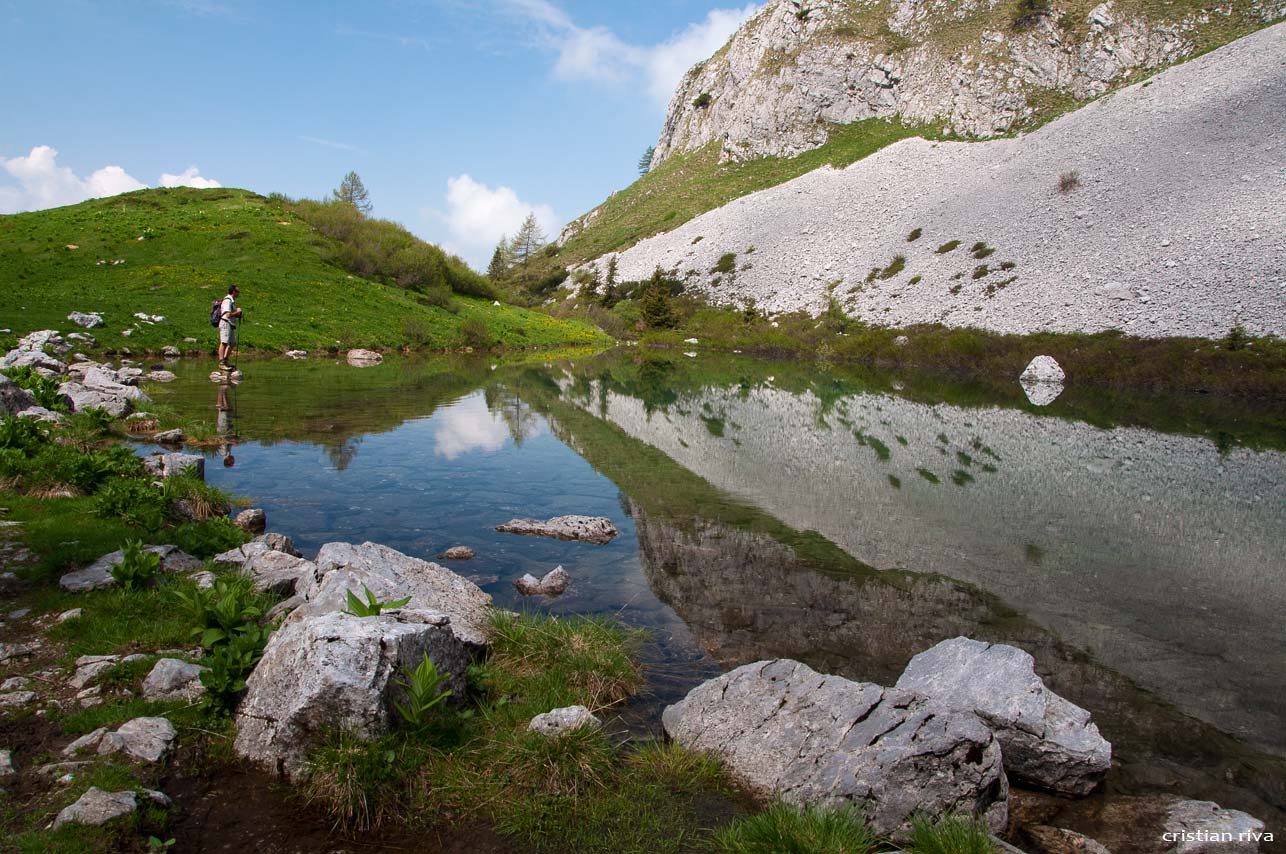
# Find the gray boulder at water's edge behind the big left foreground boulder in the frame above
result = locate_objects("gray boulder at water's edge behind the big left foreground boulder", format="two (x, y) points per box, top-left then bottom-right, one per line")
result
(289, 543), (491, 650)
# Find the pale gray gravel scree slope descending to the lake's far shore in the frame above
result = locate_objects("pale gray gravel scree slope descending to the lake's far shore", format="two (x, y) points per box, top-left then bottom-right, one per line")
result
(593, 23), (1286, 337)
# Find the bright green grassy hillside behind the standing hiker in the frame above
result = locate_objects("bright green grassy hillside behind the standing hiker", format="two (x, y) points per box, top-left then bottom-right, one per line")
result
(0, 188), (607, 352)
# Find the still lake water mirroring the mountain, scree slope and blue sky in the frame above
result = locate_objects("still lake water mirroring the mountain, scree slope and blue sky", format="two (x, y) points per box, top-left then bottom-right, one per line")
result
(157, 354), (1286, 828)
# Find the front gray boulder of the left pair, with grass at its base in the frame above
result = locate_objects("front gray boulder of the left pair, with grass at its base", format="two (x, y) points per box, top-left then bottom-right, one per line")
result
(234, 611), (471, 778)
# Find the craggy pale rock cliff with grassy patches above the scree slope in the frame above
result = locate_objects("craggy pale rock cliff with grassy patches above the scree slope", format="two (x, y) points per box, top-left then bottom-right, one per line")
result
(652, 0), (1286, 167)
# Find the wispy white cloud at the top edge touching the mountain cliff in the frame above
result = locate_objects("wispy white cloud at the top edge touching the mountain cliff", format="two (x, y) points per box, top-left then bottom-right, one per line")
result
(500, 0), (760, 107)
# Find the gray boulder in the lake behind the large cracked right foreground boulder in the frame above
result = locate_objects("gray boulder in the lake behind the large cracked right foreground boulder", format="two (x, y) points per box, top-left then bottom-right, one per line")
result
(896, 638), (1112, 795)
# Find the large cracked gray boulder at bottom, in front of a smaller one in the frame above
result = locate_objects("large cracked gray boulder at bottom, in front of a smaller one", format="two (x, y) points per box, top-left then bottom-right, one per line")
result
(661, 659), (1008, 835)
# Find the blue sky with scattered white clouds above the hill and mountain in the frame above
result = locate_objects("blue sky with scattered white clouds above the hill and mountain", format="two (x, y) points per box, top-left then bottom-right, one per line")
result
(0, 0), (755, 265)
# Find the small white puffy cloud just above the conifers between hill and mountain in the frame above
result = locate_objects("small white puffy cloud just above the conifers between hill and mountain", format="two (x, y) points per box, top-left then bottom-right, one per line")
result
(439, 175), (561, 269)
